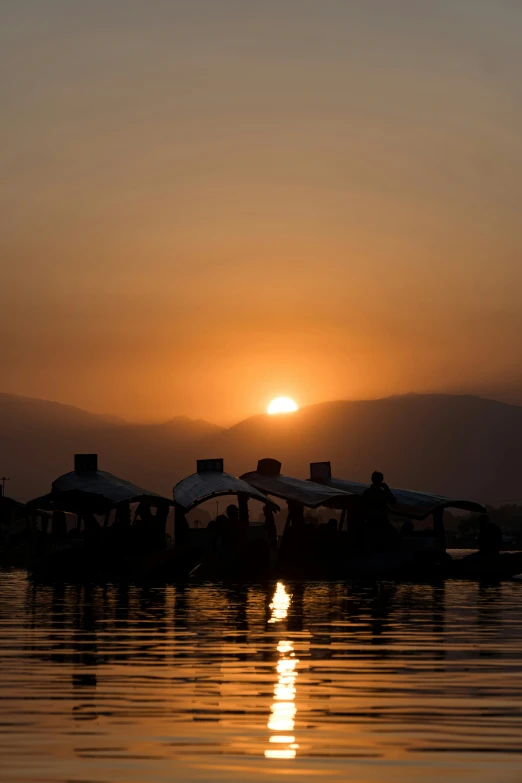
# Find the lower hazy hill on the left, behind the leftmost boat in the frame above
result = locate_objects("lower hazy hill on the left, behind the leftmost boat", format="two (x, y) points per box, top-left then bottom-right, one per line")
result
(0, 394), (220, 499)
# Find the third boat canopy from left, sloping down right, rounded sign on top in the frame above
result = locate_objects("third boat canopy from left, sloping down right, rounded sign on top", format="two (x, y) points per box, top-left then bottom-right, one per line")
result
(241, 459), (353, 508)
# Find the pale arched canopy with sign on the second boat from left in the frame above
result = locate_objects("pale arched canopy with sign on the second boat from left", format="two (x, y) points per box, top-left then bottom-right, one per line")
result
(173, 459), (279, 512)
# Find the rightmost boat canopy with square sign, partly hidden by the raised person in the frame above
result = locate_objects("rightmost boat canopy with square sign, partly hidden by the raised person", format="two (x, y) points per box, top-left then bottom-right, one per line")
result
(310, 462), (486, 520)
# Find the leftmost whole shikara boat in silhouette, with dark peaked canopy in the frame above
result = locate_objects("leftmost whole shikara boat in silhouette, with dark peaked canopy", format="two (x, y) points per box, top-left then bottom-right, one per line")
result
(26, 454), (189, 579)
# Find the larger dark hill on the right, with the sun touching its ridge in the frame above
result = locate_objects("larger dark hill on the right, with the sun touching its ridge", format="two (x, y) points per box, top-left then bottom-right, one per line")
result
(206, 395), (522, 502)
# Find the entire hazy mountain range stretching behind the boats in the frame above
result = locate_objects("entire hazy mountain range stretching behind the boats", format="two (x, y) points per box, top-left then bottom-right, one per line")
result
(0, 394), (522, 503)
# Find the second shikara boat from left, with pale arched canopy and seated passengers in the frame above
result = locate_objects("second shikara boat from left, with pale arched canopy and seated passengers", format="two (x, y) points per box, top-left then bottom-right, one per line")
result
(173, 459), (279, 581)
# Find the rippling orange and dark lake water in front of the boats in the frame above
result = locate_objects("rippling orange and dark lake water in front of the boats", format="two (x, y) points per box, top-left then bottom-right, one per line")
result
(0, 571), (522, 783)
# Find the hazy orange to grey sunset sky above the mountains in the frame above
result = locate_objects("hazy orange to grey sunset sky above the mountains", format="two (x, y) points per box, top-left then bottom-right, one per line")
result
(0, 0), (522, 421)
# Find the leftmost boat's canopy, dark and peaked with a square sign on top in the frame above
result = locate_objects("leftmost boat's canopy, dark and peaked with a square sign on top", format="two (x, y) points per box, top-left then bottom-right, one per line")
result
(27, 454), (173, 513)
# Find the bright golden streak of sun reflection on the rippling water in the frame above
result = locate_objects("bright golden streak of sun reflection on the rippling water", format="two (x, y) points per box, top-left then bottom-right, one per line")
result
(265, 582), (299, 759)
